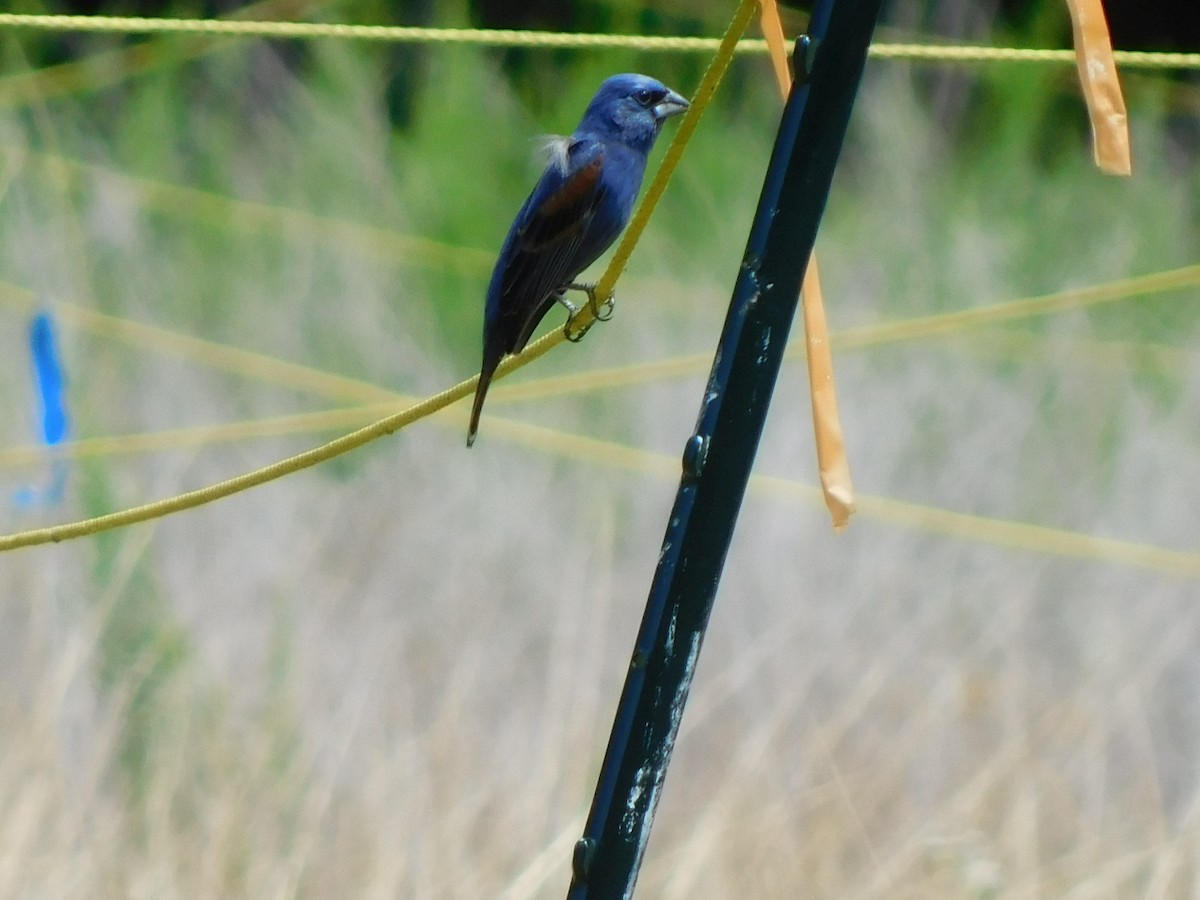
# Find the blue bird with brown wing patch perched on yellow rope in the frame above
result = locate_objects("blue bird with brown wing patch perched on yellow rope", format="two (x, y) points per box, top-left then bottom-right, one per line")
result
(467, 73), (688, 446)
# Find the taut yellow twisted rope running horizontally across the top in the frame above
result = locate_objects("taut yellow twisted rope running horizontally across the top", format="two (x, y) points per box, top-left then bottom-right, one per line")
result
(0, 13), (1200, 68)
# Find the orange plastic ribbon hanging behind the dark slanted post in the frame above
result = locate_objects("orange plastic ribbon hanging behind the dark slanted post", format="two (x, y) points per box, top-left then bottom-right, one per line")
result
(758, 0), (854, 532)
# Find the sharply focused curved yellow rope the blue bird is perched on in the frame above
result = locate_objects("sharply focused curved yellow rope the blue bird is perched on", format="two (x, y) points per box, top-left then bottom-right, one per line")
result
(0, 0), (755, 552)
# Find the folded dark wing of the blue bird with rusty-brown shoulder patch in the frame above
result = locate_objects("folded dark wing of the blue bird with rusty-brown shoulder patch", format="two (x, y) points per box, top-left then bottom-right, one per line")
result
(498, 139), (605, 353)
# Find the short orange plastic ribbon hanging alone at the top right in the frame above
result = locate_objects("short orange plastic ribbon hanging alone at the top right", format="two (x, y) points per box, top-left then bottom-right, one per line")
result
(1067, 0), (1133, 175)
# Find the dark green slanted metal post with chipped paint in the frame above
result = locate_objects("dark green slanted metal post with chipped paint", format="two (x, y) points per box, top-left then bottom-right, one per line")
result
(568, 0), (881, 900)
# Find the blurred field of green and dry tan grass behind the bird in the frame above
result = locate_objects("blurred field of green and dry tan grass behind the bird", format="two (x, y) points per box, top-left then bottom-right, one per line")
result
(0, 5), (1200, 898)
